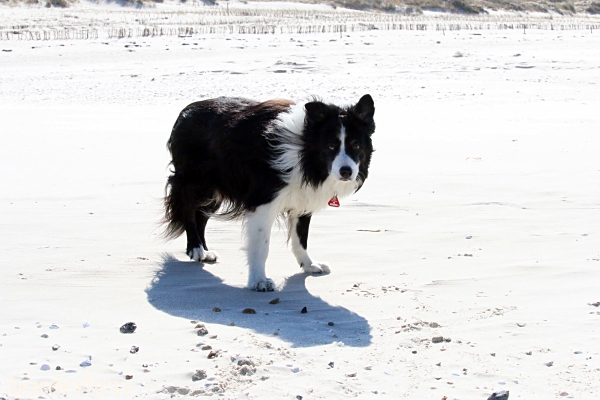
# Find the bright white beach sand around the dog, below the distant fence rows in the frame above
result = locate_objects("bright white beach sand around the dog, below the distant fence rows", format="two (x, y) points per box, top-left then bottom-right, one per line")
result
(0, 4), (600, 399)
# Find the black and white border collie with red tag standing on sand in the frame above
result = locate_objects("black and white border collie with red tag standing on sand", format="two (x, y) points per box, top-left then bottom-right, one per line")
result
(164, 95), (375, 291)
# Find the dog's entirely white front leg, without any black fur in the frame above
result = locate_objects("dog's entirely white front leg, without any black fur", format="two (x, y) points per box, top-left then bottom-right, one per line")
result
(245, 203), (277, 292)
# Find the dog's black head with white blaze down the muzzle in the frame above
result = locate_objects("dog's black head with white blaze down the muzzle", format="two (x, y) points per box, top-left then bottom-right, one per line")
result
(301, 94), (375, 189)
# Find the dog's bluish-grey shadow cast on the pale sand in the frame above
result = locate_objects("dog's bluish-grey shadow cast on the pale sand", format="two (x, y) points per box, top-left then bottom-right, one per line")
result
(146, 255), (371, 347)
